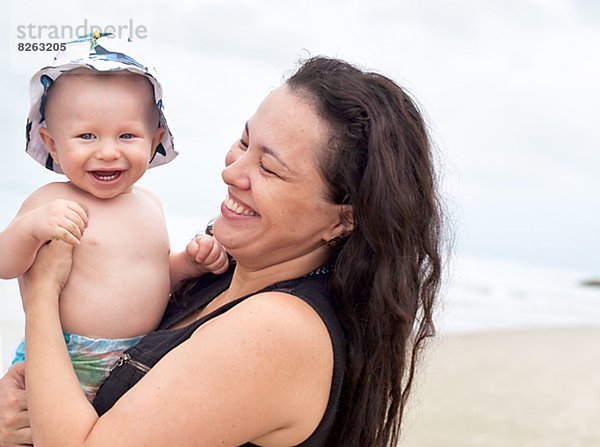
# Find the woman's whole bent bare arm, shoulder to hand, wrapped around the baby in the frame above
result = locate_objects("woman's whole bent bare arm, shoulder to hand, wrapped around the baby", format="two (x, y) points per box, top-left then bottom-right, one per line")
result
(25, 244), (333, 447)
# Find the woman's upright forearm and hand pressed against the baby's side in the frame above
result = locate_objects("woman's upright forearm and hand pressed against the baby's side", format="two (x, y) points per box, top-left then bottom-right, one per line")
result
(19, 241), (97, 446)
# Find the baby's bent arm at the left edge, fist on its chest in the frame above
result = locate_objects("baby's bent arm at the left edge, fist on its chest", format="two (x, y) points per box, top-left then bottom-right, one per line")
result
(0, 188), (87, 279)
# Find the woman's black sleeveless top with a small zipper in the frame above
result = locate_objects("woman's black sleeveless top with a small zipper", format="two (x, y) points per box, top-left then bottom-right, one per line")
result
(93, 268), (345, 447)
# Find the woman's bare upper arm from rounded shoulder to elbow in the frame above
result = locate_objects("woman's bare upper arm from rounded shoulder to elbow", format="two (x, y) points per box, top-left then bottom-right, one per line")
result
(90, 293), (333, 447)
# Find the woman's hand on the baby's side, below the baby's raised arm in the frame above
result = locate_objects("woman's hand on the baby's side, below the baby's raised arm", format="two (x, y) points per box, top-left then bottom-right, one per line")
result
(19, 241), (73, 313)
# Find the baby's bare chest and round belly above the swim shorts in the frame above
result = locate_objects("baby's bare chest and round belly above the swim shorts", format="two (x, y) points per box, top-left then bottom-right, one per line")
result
(56, 192), (170, 337)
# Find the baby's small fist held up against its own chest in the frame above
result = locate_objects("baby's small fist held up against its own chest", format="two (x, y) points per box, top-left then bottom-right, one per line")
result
(28, 199), (88, 246)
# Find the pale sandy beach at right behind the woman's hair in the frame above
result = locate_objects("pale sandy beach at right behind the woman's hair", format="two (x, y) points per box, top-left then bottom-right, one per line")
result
(399, 327), (600, 447)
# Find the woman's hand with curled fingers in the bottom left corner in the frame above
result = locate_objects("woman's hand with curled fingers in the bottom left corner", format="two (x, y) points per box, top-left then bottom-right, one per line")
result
(0, 362), (33, 447)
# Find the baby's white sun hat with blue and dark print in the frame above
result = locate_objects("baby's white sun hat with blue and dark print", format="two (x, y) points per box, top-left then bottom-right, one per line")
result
(25, 31), (177, 174)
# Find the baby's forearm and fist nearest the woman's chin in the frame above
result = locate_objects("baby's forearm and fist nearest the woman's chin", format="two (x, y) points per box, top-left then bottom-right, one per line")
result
(169, 235), (229, 289)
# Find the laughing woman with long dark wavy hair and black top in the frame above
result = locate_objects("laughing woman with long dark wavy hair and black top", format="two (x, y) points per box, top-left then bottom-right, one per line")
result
(0, 58), (440, 447)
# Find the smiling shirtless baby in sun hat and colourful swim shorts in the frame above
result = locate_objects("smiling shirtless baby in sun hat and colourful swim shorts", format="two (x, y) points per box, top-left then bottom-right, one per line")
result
(0, 33), (227, 400)
